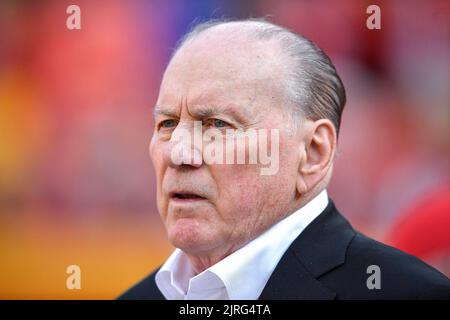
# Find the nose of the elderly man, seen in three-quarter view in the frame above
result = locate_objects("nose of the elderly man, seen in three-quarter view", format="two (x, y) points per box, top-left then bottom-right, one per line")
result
(163, 124), (203, 168)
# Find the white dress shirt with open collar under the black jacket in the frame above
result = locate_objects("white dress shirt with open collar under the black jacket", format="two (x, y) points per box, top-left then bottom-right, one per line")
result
(156, 190), (328, 300)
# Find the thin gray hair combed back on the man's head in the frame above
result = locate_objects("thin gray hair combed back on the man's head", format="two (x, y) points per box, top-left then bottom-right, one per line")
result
(174, 19), (346, 134)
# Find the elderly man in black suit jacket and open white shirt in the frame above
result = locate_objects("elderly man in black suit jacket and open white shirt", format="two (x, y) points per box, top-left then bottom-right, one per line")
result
(121, 20), (450, 299)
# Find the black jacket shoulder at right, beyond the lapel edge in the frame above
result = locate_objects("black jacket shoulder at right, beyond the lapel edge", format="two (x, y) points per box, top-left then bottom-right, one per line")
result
(322, 232), (450, 299)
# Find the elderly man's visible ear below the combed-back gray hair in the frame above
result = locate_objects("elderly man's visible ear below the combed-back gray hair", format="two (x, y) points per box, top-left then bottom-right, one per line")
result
(297, 119), (337, 194)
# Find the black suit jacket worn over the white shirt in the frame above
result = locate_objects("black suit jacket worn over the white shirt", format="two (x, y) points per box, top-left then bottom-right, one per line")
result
(119, 200), (450, 300)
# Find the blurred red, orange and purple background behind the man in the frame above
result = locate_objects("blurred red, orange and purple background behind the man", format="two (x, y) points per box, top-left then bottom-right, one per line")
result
(0, 0), (450, 299)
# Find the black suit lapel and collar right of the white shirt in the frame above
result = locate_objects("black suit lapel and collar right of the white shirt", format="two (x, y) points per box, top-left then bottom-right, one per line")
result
(259, 199), (355, 300)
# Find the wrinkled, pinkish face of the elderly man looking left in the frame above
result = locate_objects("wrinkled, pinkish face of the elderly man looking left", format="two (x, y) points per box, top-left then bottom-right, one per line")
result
(150, 32), (299, 255)
